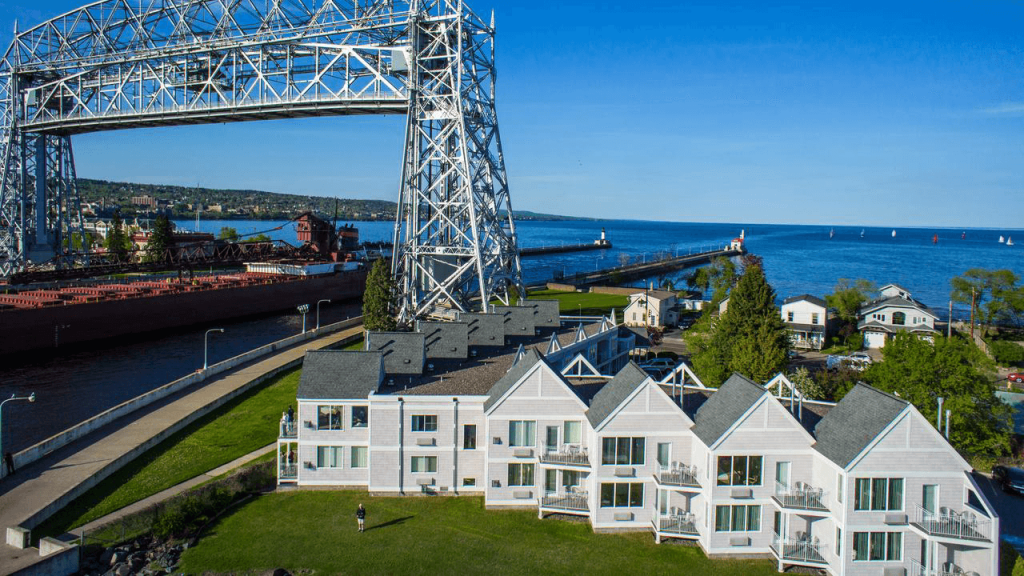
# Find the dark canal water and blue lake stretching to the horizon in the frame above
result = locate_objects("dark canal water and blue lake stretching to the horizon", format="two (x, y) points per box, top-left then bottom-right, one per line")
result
(0, 220), (1024, 451)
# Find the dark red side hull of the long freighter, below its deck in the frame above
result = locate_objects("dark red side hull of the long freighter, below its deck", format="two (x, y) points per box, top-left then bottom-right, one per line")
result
(0, 270), (367, 355)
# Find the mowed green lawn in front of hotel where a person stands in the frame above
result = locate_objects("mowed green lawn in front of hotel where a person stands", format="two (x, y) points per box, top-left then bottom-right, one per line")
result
(180, 491), (776, 576)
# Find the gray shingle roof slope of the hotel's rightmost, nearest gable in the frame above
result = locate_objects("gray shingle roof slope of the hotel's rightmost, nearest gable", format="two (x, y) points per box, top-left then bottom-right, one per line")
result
(814, 383), (907, 468)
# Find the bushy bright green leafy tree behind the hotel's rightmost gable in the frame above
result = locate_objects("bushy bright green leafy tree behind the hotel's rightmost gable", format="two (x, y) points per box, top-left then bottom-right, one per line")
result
(863, 333), (1012, 454)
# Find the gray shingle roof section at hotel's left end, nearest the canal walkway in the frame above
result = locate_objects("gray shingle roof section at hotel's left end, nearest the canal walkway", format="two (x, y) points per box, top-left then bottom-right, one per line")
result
(296, 351), (384, 400)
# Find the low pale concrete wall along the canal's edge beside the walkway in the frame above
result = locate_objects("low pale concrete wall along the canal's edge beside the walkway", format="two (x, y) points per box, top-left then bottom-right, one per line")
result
(0, 316), (362, 478)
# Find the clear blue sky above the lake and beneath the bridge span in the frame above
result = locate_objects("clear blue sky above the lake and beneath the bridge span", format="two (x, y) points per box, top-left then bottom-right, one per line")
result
(0, 0), (1024, 228)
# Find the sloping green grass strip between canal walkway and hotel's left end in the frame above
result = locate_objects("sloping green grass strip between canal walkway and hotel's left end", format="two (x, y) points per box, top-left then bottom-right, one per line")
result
(33, 369), (301, 536)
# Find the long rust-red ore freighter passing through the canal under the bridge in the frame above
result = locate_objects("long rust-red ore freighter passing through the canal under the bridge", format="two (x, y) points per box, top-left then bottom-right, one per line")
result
(0, 214), (367, 355)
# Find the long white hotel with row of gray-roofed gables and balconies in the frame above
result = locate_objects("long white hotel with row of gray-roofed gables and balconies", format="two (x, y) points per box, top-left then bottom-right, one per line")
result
(279, 302), (999, 576)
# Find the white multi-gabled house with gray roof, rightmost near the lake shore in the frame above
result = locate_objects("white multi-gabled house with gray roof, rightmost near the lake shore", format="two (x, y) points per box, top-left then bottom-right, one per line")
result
(857, 284), (939, 348)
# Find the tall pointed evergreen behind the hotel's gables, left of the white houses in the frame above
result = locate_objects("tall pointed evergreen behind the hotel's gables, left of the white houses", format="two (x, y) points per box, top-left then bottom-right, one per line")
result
(686, 265), (790, 386)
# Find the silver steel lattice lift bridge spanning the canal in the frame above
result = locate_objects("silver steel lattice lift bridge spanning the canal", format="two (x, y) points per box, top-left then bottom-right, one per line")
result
(0, 0), (523, 322)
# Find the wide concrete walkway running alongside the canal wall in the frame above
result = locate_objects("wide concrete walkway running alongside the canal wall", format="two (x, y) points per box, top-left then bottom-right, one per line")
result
(0, 326), (362, 574)
